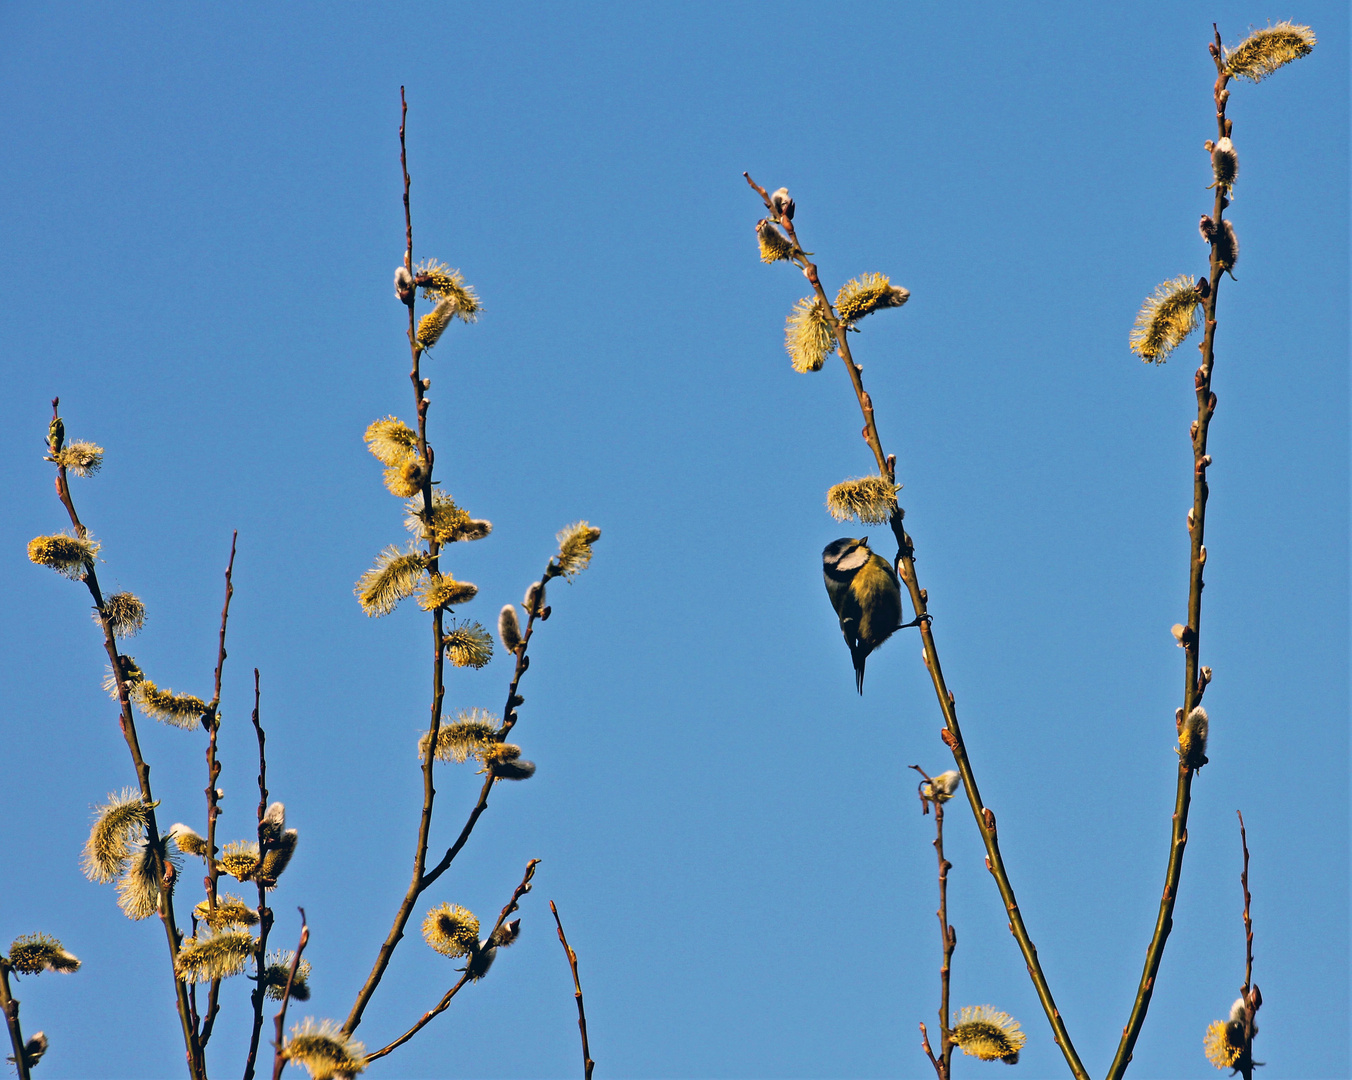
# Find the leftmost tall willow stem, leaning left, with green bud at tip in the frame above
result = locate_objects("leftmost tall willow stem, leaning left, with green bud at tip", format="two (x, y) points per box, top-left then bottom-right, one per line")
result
(51, 397), (206, 1080)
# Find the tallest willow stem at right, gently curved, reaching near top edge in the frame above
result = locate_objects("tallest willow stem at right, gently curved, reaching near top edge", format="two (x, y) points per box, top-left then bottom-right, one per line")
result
(1106, 27), (1230, 1080)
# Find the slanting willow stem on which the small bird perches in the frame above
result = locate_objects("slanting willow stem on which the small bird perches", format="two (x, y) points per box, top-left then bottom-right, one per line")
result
(742, 181), (1088, 1080)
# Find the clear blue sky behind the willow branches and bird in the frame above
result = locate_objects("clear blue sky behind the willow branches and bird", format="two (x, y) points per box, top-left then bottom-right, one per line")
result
(0, 0), (1349, 1080)
